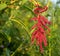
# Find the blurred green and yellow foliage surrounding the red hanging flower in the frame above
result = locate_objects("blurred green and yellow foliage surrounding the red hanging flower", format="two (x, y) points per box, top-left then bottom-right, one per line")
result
(0, 0), (60, 56)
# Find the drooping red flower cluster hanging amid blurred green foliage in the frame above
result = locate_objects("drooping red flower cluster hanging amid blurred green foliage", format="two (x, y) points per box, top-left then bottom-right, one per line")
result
(32, 6), (50, 53)
